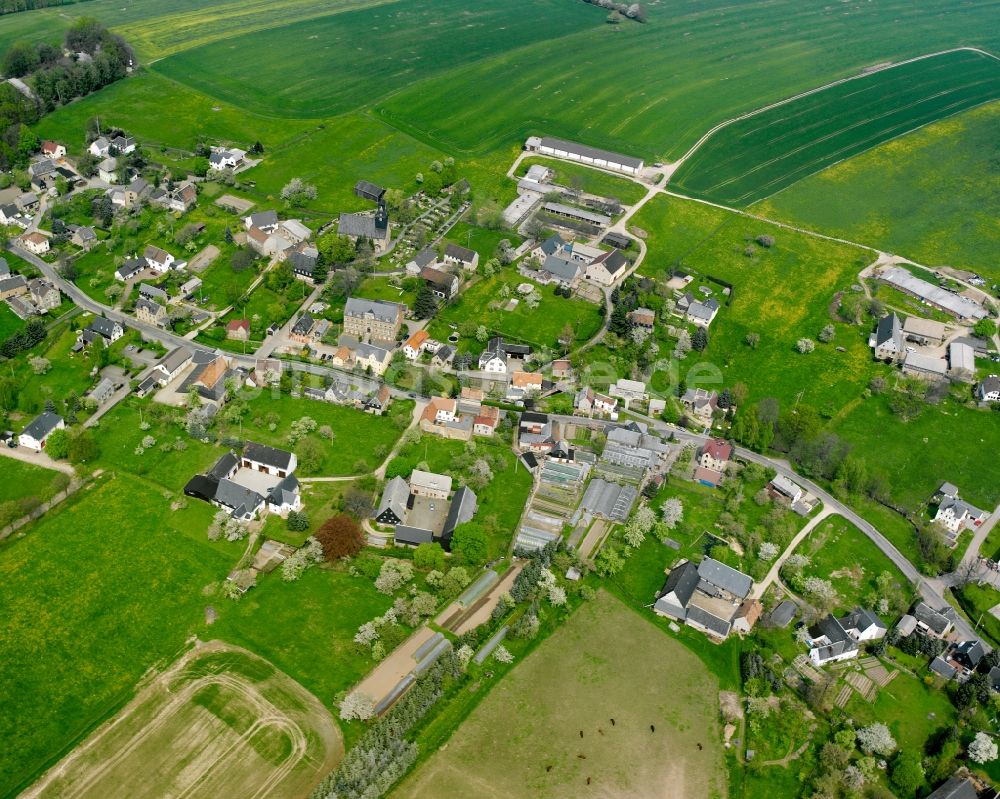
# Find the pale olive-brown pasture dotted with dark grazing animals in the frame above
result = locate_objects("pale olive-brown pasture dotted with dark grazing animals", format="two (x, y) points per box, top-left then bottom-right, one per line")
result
(392, 592), (725, 799)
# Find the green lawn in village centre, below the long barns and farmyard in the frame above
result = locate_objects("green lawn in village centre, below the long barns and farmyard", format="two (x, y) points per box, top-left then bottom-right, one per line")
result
(428, 268), (601, 351)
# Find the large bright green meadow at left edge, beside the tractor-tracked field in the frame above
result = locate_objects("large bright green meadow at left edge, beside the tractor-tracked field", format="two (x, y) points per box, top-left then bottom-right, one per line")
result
(0, 477), (230, 796)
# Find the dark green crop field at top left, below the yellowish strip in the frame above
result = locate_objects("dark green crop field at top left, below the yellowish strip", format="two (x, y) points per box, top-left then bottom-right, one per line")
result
(149, 0), (605, 118)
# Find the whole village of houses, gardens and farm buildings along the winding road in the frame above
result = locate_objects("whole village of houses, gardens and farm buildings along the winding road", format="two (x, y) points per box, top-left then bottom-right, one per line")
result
(0, 120), (1000, 799)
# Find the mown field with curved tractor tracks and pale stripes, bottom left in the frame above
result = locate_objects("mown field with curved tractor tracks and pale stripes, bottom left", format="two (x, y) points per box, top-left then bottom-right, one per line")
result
(24, 642), (343, 799)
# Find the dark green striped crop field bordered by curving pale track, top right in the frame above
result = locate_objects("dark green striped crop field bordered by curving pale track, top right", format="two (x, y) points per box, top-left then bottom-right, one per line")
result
(672, 50), (1000, 206)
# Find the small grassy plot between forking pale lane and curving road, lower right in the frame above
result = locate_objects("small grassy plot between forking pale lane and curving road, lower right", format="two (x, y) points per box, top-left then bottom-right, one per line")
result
(795, 516), (906, 613)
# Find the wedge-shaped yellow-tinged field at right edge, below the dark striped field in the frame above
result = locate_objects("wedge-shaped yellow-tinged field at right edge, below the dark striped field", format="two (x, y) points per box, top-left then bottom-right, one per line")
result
(753, 103), (1000, 280)
